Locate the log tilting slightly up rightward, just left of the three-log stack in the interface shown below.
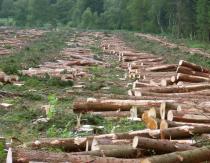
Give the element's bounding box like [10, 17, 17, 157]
[146, 64, 177, 72]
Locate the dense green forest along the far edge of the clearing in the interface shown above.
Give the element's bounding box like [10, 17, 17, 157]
[0, 0, 210, 40]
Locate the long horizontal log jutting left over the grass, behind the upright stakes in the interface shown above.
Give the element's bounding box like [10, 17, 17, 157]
[74, 98, 173, 112]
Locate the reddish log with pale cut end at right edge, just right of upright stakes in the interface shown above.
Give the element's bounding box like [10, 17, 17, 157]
[167, 110, 210, 123]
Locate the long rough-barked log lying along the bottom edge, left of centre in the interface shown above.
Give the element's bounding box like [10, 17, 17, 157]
[13, 149, 140, 163]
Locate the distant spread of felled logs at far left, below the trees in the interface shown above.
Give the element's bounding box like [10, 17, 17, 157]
[0, 29, 47, 56]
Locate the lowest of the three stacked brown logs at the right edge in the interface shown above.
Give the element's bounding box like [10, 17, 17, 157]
[177, 73, 210, 83]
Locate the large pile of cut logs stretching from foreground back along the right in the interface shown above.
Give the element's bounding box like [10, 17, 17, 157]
[9, 36, 210, 163]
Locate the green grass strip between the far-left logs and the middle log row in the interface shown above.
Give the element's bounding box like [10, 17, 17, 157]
[0, 30, 71, 74]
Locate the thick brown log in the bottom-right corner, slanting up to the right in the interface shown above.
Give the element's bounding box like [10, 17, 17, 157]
[141, 146, 210, 163]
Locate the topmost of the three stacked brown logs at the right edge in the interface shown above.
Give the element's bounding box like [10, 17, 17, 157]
[179, 60, 210, 73]
